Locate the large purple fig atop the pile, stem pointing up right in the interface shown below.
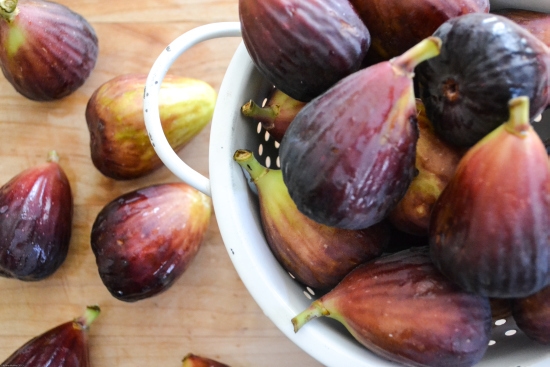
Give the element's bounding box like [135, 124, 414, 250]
[280, 37, 440, 229]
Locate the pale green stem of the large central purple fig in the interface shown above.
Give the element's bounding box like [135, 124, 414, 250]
[390, 37, 442, 78]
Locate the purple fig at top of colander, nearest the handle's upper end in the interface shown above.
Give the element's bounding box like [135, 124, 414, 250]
[239, 0, 370, 102]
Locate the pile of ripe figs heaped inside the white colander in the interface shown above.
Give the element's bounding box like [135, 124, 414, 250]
[240, 0, 550, 367]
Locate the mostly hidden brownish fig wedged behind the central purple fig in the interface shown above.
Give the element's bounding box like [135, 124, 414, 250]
[388, 99, 463, 236]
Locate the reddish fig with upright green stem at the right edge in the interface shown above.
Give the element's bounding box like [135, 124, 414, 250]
[429, 96, 550, 298]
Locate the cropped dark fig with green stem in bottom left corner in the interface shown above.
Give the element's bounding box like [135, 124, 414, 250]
[0, 306, 100, 367]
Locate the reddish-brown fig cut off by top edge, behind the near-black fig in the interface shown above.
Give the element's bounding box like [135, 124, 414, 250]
[350, 0, 489, 61]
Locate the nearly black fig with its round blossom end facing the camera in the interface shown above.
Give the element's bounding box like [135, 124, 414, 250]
[416, 13, 550, 147]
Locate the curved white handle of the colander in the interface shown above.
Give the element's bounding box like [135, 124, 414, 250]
[143, 22, 241, 196]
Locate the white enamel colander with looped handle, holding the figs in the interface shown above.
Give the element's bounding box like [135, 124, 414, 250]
[144, 0, 550, 367]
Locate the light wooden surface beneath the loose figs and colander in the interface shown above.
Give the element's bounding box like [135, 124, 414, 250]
[0, 0, 319, 367]
